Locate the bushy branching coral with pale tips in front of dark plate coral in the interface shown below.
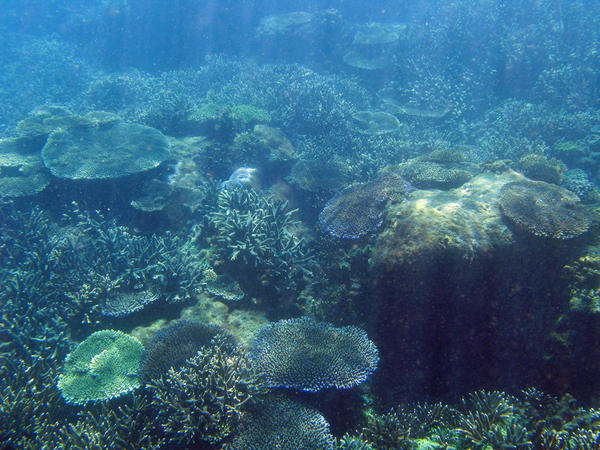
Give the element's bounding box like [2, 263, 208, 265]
[147, 345, 266, 444]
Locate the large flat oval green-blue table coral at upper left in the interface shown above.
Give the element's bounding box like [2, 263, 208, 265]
[42, 118, 170, 180]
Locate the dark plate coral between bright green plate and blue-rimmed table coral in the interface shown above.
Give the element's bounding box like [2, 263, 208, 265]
[140, 320, 235, 382]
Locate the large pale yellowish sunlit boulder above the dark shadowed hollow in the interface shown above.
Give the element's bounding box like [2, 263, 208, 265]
[370, 172, 520, 270]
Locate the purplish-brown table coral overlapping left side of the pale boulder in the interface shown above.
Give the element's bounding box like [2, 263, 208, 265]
[319, 172, 413, 239]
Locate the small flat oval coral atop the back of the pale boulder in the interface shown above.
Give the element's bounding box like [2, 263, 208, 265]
[398, 158, 472, 189]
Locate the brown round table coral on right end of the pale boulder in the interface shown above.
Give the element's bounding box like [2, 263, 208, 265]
[499, 180, 592, 239]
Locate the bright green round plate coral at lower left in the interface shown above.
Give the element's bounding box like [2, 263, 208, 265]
[58, 330, 144, 405]
